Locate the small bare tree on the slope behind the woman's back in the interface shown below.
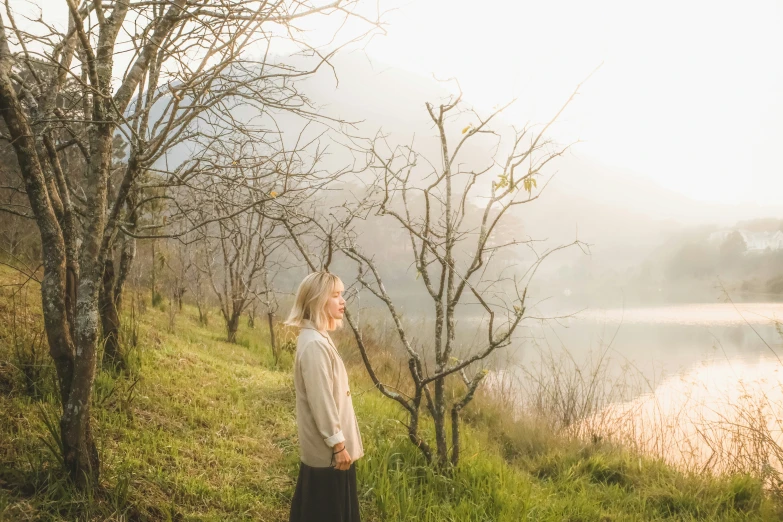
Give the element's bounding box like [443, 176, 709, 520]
[199, 136, 304, 343]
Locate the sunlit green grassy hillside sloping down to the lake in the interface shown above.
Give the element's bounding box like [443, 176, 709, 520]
[0, 271, 783, 522]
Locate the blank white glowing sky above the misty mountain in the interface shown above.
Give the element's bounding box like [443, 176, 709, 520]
[367, 0, 783, 204]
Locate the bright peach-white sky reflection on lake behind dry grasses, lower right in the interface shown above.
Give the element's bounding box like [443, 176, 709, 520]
[578, 356, 783, 480]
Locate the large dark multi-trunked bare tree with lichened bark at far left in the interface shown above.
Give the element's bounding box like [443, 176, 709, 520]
[0, 0, 377, 485]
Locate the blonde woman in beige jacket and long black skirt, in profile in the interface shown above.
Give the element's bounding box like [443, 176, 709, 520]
[286, 272, 364, 522]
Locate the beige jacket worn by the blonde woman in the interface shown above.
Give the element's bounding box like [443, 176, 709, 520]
[294, 322, 364, 468]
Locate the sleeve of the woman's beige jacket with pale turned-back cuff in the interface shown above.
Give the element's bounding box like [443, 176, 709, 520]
[300, 341, 345, 447]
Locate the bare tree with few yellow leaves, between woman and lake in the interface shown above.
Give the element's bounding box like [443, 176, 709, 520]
[292, 85, 586, 468]
